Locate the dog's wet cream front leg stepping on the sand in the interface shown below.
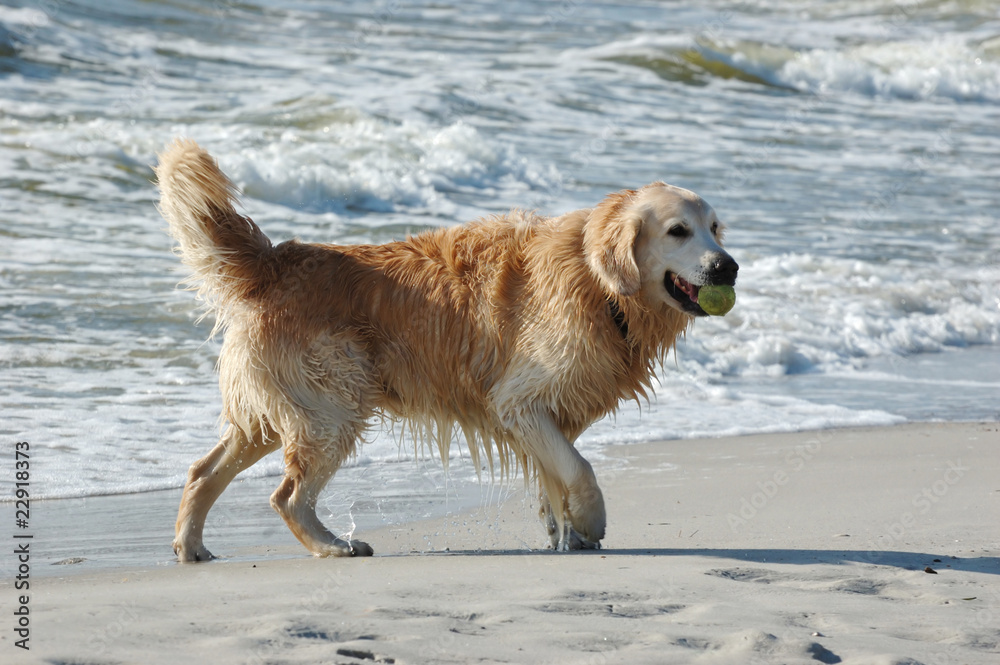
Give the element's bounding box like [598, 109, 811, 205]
[513, 411, 607, 550]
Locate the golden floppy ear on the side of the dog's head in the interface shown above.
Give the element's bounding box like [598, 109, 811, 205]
[583, 190, 644, 296]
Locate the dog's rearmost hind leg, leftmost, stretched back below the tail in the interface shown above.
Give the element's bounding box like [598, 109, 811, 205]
[174, 424, 281, 562]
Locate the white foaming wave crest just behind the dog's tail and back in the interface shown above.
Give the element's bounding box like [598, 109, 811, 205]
[219, 114, 560, 216]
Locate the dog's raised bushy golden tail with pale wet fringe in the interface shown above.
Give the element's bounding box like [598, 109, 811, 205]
[156, 139, 274, 327]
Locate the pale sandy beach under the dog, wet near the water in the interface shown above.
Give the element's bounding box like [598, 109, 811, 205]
[0, 423, 1000, 665]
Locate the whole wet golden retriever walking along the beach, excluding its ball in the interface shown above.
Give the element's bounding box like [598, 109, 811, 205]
[156, 140, 738, 561]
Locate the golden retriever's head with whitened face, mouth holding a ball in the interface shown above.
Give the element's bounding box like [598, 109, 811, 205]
[584, 182, 739, 316]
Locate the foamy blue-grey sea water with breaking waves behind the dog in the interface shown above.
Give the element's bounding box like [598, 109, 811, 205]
[0, 0, 1000, 508]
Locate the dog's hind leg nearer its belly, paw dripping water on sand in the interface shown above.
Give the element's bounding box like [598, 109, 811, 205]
[271, 426, 372, 557]
